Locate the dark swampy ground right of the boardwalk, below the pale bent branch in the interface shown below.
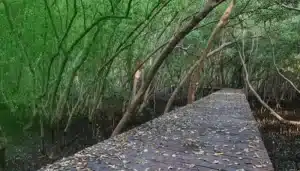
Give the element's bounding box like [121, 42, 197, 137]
[256, 111, 300, 171]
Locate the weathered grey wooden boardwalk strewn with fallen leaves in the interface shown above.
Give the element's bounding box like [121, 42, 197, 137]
[40, 89, 274, 171]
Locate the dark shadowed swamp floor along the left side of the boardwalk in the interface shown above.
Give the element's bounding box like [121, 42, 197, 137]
[0, 104, 98, 171]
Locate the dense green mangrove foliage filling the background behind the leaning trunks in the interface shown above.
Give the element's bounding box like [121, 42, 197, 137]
[0, 0, 300, 128]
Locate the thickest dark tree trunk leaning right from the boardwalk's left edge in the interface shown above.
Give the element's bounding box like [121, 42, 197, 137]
[111, 0, 226, 137]
